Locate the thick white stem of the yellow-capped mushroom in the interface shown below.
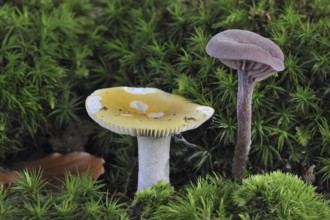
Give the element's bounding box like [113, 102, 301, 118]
[137, 136, 171, 191]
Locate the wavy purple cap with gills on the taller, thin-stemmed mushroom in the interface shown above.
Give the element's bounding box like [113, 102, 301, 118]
[206, 29, 284, 81]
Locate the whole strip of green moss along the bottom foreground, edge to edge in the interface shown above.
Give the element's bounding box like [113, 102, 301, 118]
[0, 172, 330, 220]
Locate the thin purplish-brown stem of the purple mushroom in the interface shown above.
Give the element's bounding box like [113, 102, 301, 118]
[232, 70, 254, 181]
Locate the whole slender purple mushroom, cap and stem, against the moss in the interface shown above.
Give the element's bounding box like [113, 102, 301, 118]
[206, 29, 284, 180]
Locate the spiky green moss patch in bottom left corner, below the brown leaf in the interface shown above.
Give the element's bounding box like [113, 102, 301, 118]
[0, 172, 128, 220]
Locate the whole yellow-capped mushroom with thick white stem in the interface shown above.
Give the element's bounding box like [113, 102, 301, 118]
[86, 87, 214, 191]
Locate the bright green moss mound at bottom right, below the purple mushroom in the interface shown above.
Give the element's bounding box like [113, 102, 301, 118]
[150, 171, 330, 219]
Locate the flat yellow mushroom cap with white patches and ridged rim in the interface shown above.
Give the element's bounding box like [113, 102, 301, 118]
[86, 87, 214, 137]
